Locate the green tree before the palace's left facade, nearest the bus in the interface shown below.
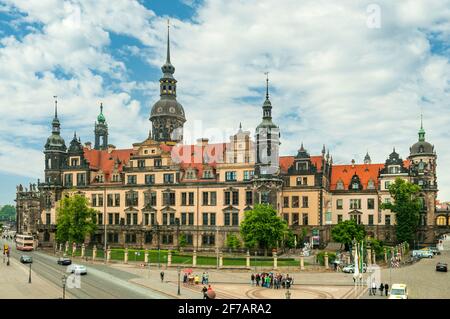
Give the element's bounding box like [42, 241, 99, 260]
[56, 194, 97, 243]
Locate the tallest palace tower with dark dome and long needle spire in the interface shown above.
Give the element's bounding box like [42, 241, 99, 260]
[150, 21, 186, 143]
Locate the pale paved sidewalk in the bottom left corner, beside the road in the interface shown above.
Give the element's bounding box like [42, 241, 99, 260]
[0, 256, 61, 299]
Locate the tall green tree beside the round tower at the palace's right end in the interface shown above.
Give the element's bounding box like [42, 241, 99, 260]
[381, 178, 422, 243]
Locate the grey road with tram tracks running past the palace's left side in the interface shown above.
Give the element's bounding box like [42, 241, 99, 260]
[1, 241, 171, 299]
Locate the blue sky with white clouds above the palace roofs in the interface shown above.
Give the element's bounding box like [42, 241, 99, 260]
[0, 0, 450, 204]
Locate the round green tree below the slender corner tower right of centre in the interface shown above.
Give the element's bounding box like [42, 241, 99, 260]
[240, 204, 288, 255]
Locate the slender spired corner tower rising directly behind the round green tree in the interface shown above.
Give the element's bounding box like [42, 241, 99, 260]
[253, 73, 283, 209]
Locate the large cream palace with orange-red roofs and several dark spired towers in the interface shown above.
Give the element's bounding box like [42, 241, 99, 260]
[16, 26, 444, 250]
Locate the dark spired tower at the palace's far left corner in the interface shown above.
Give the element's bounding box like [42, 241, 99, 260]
[44, 99, 67, 186]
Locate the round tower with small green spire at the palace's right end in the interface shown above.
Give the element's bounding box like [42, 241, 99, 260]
[408, 119, 438, 226]
